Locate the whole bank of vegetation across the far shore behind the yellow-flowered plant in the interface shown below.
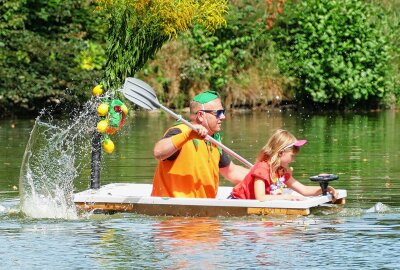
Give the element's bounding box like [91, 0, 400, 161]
[0, 0, 400, 118]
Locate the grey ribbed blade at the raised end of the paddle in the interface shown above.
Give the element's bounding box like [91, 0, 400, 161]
[122, 77, 160, 110]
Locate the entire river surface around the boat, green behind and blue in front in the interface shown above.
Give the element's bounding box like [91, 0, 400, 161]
[0, 111, 400, 269]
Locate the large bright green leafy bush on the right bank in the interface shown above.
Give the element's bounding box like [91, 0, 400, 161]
[272, 0, 393, 107]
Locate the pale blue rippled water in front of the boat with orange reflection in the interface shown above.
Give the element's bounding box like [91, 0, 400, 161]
[0, 197, 400, 269]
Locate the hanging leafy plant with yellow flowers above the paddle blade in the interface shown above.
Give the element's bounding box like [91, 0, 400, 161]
[97, 0, 227, 86]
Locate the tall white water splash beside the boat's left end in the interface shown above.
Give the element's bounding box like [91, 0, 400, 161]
[19, 101, 97, 219]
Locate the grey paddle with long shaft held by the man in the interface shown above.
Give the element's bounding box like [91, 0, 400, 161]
[122, 77, 253, 168]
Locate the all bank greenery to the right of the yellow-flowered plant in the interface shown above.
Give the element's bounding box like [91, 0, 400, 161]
[142, 0, 400, 109]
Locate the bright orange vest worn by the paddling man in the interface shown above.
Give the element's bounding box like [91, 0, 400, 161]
[151, 124, 221, 198]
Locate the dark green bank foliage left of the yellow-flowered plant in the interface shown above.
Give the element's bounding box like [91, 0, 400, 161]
[0, 0, 105, 114]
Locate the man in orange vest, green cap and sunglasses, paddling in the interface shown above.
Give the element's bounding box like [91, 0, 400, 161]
[151, 90, 249, 198]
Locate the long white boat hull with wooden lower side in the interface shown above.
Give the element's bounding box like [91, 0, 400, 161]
[74, 183, 347, 216]
